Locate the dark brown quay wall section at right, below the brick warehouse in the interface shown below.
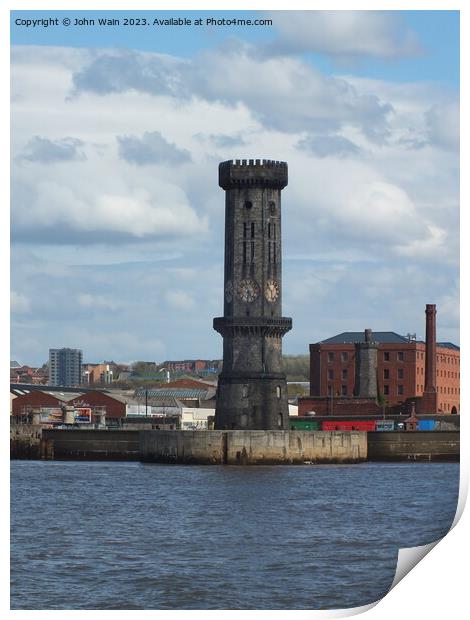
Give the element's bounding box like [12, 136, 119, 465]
[367, 431, 460, 461]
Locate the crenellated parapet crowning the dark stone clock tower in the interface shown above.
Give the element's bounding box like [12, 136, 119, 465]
[219, 159, 287, 190]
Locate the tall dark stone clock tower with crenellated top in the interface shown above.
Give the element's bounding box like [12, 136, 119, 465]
[214, 159, 292, 430]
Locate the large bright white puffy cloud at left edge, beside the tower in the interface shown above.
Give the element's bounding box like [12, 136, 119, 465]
[12, 149, 207, 243]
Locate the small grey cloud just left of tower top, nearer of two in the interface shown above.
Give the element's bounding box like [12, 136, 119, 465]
[117, 131, 191, 166]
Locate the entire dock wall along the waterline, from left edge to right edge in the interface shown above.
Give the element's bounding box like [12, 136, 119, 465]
[10, 424, 460, 465]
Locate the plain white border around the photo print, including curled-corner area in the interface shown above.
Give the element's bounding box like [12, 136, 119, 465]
[0, 0, 470, 620]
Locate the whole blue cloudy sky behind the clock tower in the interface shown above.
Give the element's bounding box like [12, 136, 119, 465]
[11, 11, 460, 365]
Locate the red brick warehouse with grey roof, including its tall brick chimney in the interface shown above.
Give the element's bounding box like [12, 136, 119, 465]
[300, 304, 460, 415]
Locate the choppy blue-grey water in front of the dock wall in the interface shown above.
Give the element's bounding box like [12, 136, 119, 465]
[11, 461, 459, 609]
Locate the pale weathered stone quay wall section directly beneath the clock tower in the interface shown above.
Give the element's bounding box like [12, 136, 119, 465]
[140, 431, 367, 465]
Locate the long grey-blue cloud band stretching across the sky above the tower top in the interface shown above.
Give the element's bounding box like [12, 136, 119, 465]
[73, 42, 392, 142]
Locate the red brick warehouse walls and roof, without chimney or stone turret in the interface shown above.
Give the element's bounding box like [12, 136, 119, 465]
[299, 306, 460, 415]
